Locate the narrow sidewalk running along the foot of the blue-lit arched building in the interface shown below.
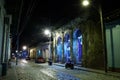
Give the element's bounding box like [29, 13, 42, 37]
[53, 63, 120, 78]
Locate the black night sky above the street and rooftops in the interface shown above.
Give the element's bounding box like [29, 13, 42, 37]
[5, 0, 119, 49]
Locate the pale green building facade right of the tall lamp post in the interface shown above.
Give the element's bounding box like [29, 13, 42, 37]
[105, 19, 120, 72]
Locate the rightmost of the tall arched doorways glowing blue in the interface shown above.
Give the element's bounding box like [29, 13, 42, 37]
[73, 29, 82, 64]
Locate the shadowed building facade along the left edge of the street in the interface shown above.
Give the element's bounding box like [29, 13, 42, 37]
[0, 0, 11, 76]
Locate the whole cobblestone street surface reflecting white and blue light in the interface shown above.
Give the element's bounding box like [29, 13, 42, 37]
[2, 60, 120, 80]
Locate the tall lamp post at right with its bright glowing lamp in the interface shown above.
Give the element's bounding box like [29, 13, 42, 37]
[82, 0, 107, 72]
